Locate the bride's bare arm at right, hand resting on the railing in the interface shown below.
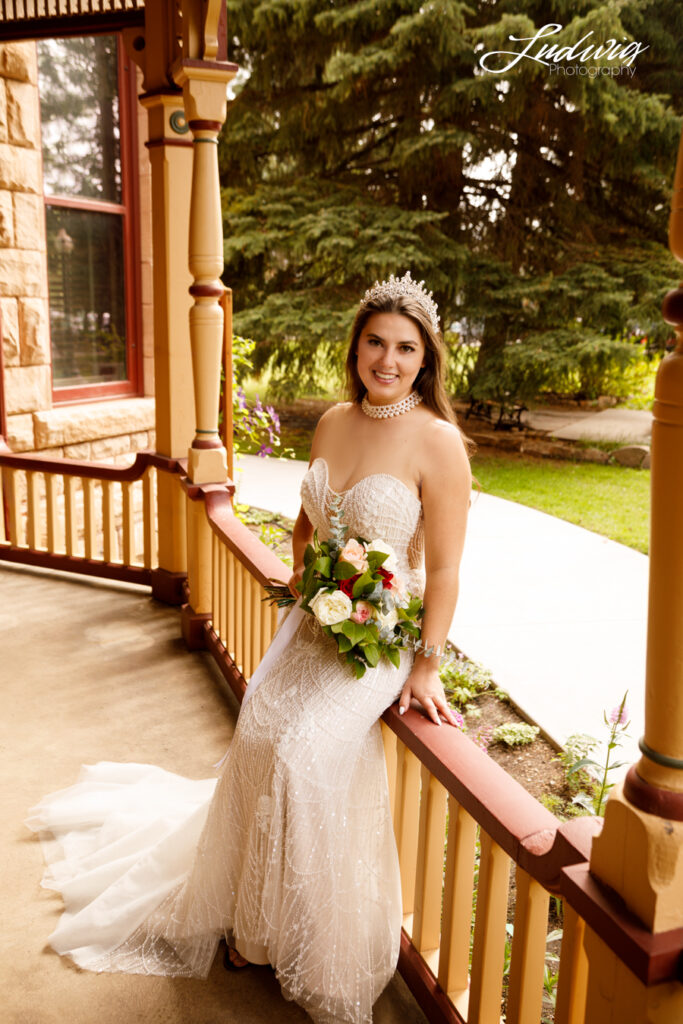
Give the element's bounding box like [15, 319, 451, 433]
[398, 421, 472, 725]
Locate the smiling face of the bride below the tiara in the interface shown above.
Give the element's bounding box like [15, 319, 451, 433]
[356, 313, 425, 406]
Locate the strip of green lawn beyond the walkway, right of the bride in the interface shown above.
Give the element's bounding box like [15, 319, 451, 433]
[472, 456, 650, 554]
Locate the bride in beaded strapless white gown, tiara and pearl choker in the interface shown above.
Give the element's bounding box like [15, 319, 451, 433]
[28, 272, 471, 1024]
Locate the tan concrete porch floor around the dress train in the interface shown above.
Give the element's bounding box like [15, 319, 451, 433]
[0, 566, 426, 1024]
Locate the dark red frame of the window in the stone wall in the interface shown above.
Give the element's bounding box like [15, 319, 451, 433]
[38, 30, 142, 407]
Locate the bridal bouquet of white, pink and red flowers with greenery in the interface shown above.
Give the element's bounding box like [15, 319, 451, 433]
[267, 499, 434, 679]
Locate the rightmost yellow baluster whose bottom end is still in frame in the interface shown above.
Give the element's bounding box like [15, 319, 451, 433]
[438, 796, 477, 1003]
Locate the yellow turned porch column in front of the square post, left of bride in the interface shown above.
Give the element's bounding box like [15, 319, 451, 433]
[173, 0, 237, 647]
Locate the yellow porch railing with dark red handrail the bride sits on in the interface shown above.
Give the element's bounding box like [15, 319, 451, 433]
[0, 447, 683, 1024]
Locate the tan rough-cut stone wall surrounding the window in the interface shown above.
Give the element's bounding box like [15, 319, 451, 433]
[0, 42, 155, 461]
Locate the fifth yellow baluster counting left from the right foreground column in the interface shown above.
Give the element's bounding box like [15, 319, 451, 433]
[413, 765, 449, 973]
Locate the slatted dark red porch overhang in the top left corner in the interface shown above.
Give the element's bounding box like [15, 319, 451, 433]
[0, 0, 144, 42]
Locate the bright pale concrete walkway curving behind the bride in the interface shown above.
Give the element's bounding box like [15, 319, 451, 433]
[237, 452, 648, 777]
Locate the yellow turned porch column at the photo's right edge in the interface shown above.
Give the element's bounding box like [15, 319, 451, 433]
[586, 125, 683, 1024]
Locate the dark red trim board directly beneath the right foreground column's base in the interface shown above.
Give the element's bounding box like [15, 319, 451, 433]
[562, 864, 683, 985]
